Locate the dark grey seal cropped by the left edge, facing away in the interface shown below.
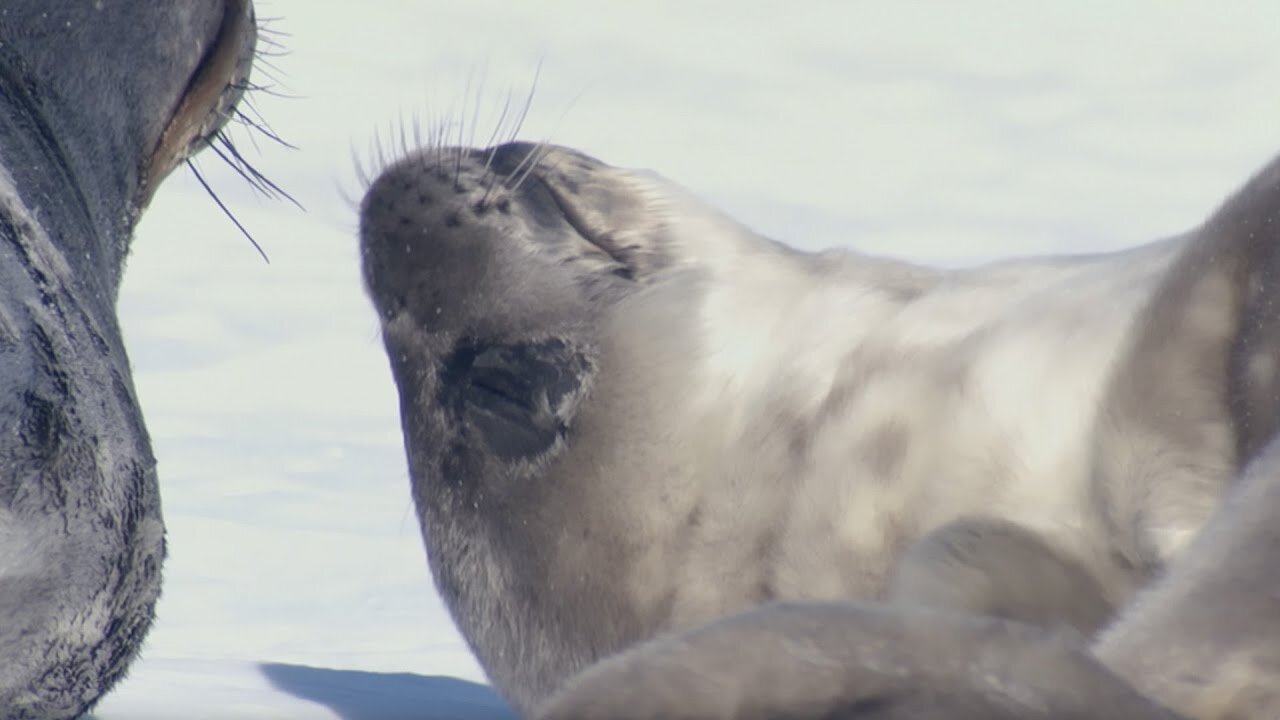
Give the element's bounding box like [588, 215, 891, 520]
[0, 0, 256, 719]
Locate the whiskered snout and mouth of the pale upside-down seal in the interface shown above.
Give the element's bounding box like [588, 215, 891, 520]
[361, 142, 669, 327]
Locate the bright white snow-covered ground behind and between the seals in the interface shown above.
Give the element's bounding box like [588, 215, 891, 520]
[95, 0, 1280, 720]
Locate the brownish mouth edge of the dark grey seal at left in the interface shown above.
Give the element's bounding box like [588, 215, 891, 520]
[137, 0, 257, 208]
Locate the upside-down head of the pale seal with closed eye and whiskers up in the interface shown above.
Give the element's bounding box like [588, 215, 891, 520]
[361, 142, 808, 707]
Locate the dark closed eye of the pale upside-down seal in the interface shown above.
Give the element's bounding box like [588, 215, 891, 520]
[440, 338, 589, 461]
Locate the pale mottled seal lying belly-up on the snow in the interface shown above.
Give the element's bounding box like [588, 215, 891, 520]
[361, 143, 1280, 719]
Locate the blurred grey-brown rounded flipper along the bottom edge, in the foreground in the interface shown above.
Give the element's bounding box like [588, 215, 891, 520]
[535, 603, 1179, 720]
